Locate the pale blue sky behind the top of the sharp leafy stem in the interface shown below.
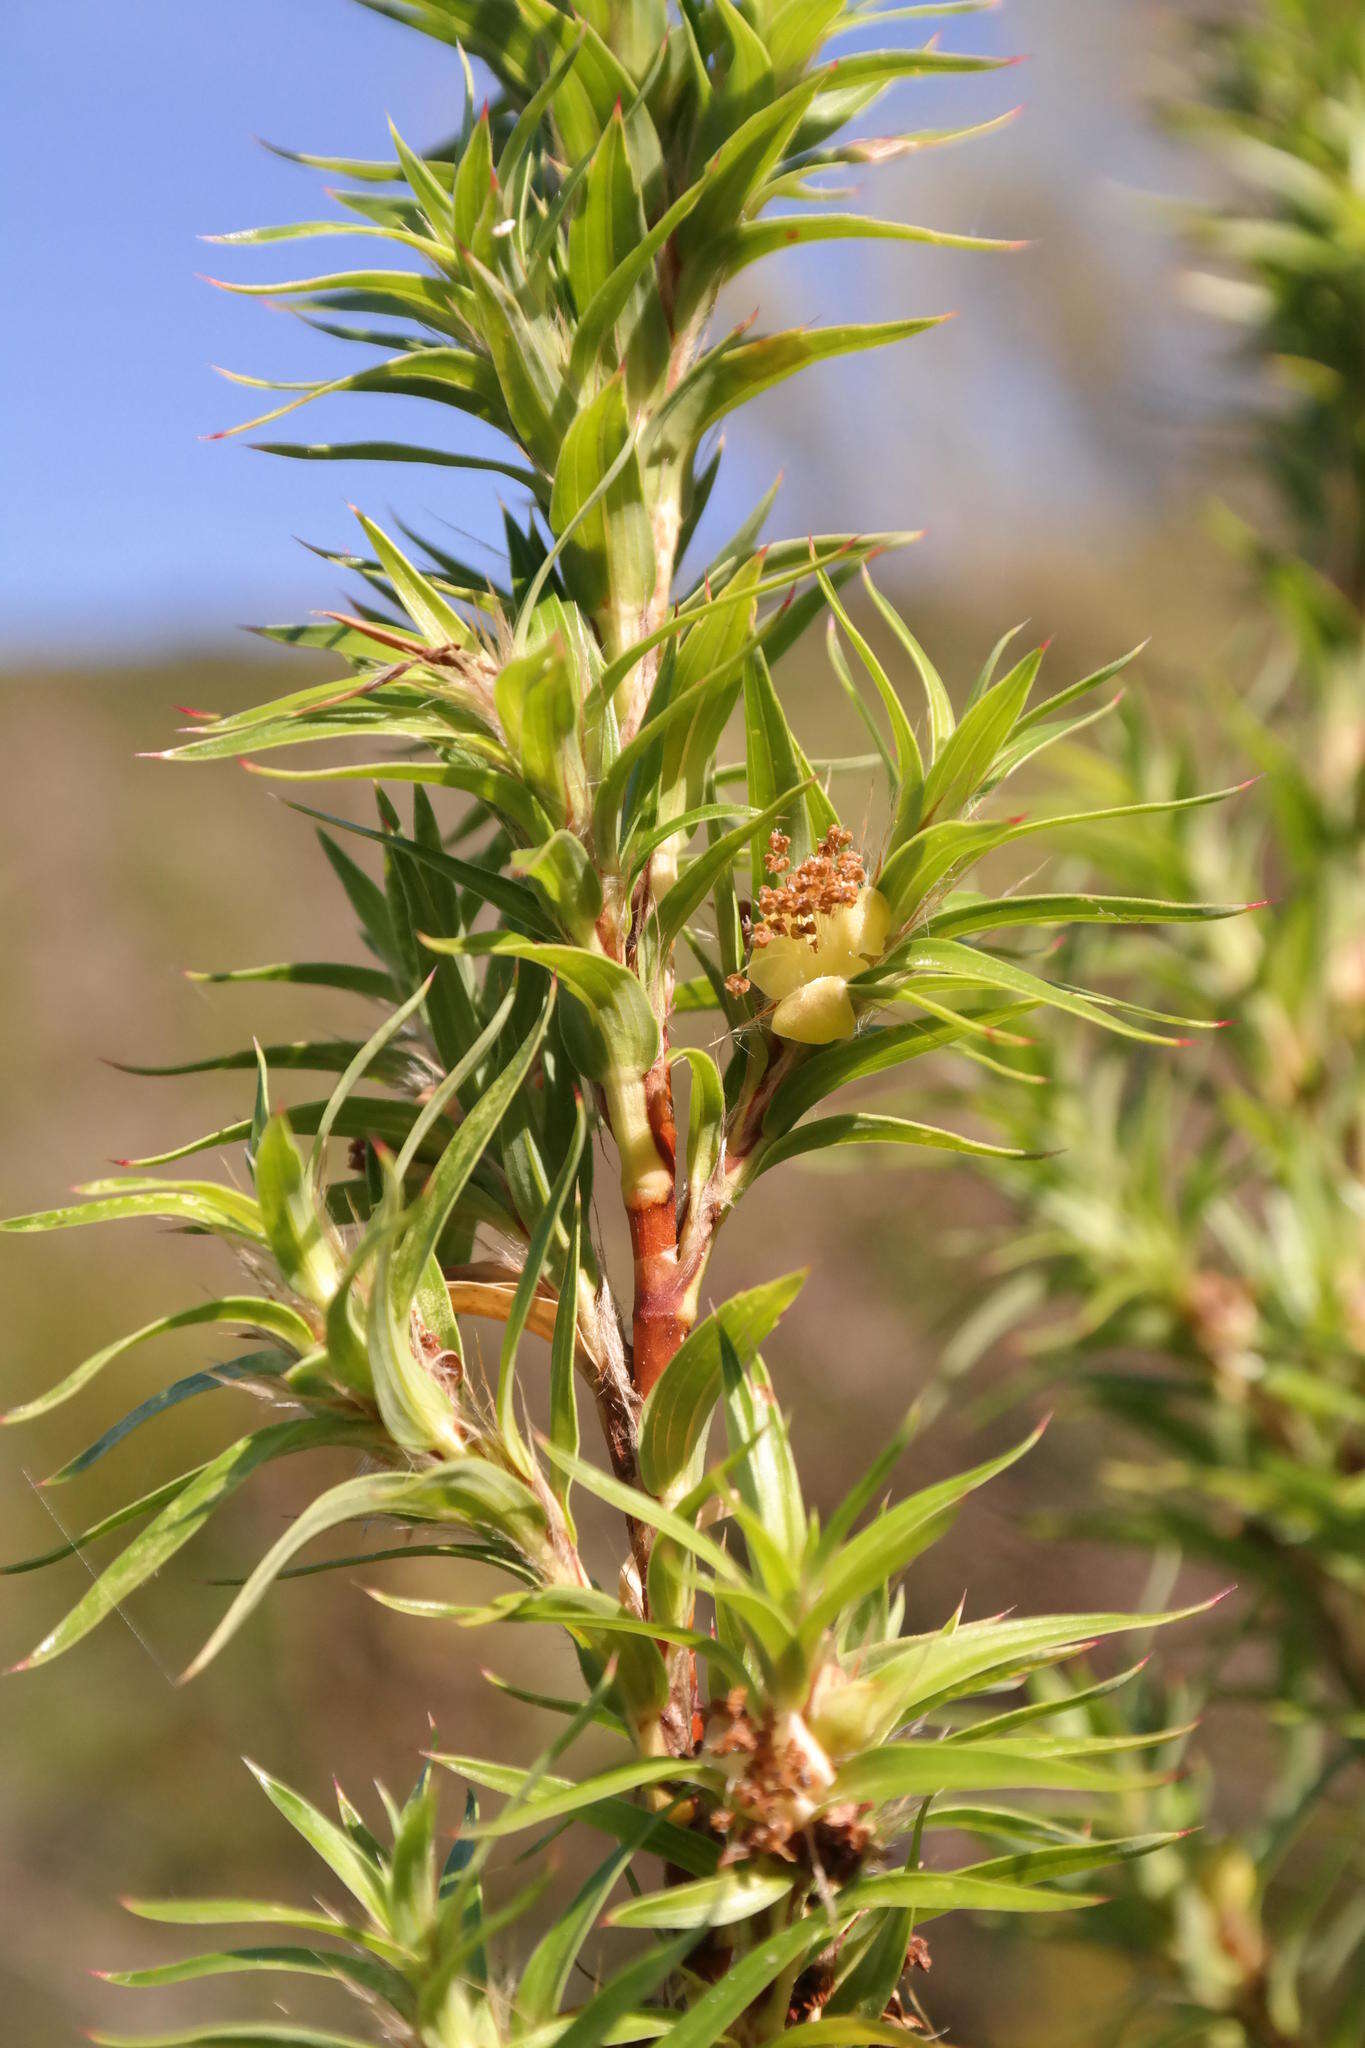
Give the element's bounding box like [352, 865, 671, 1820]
[0, 0, 1203, 655]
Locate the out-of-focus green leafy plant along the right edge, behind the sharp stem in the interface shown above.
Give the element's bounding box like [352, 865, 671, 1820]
[948, 0, 1365, 2048]
